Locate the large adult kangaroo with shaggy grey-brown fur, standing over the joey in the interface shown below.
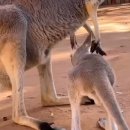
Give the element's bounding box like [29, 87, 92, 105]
[0, 0, 104, 130]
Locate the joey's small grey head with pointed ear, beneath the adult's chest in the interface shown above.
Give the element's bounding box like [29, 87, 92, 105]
[71, 34, 92, 66]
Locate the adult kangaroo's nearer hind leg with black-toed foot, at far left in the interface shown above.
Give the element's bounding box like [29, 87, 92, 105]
[0, 5, 58, 130]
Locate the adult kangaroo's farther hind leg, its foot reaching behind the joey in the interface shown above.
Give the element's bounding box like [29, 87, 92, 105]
[38, 59, 69, 106]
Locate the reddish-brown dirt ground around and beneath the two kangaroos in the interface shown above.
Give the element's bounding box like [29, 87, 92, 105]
[0, 4, 130, 130]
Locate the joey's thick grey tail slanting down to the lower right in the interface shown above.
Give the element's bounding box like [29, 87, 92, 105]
[95, 77, 129, 130]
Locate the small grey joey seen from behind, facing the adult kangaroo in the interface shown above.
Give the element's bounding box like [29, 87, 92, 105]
[68, 35, 129, 130]
